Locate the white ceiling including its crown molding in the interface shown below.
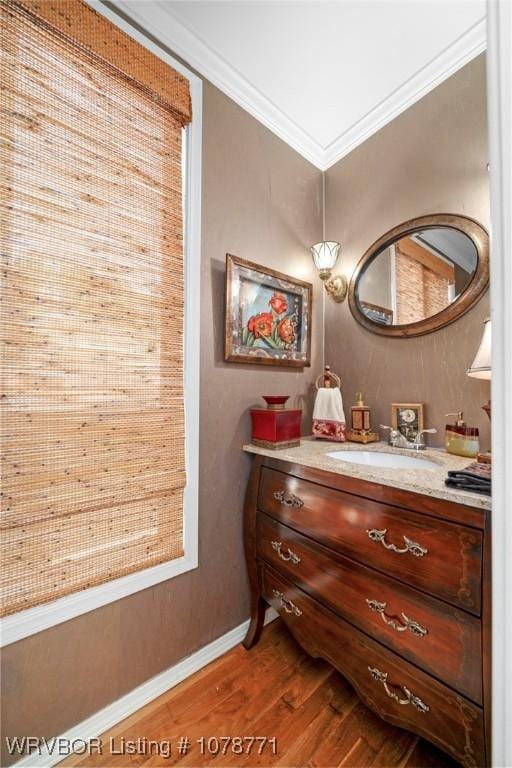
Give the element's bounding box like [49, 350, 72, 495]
[115, 0, 485, 170]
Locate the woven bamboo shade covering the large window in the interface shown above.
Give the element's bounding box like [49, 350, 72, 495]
[0, 0, 191, 615]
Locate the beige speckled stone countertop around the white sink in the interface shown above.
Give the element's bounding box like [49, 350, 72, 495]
[243, 437, 491, 509]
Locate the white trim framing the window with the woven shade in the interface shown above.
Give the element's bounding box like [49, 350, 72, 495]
[0, 0, 203, 646]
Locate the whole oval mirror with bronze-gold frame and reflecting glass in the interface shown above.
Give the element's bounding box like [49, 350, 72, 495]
[349, 214, 489, 336]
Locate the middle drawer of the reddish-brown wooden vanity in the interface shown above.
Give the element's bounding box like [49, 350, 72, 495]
[257, 512, 482, 704]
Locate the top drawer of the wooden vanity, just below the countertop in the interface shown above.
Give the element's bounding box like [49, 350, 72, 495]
[258, 468, 482, 615]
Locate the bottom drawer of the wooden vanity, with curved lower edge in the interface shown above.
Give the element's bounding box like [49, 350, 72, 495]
[261, 567, 485, 768]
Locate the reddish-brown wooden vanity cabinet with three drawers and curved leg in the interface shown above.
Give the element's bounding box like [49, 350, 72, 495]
[244, 456, 490, 768]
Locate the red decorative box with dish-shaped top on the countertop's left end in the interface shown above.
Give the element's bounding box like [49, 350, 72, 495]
[250, 395, 302, 450]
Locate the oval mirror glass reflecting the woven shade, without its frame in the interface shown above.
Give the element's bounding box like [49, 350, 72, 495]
[355, 227, 478, 325]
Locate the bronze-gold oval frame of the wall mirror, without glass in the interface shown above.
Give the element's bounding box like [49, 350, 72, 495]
[348, 213, 489, 338]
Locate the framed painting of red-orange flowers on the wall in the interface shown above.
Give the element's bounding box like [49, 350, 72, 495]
[224, 253, 312, 368]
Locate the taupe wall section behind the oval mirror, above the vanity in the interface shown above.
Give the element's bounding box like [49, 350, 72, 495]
[325, 55, 489, 447]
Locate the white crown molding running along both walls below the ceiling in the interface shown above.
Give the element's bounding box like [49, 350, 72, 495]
[110, 0, 486, 171]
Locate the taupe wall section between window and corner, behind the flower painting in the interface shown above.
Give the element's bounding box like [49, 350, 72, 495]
[2, 83, 322, 765]
